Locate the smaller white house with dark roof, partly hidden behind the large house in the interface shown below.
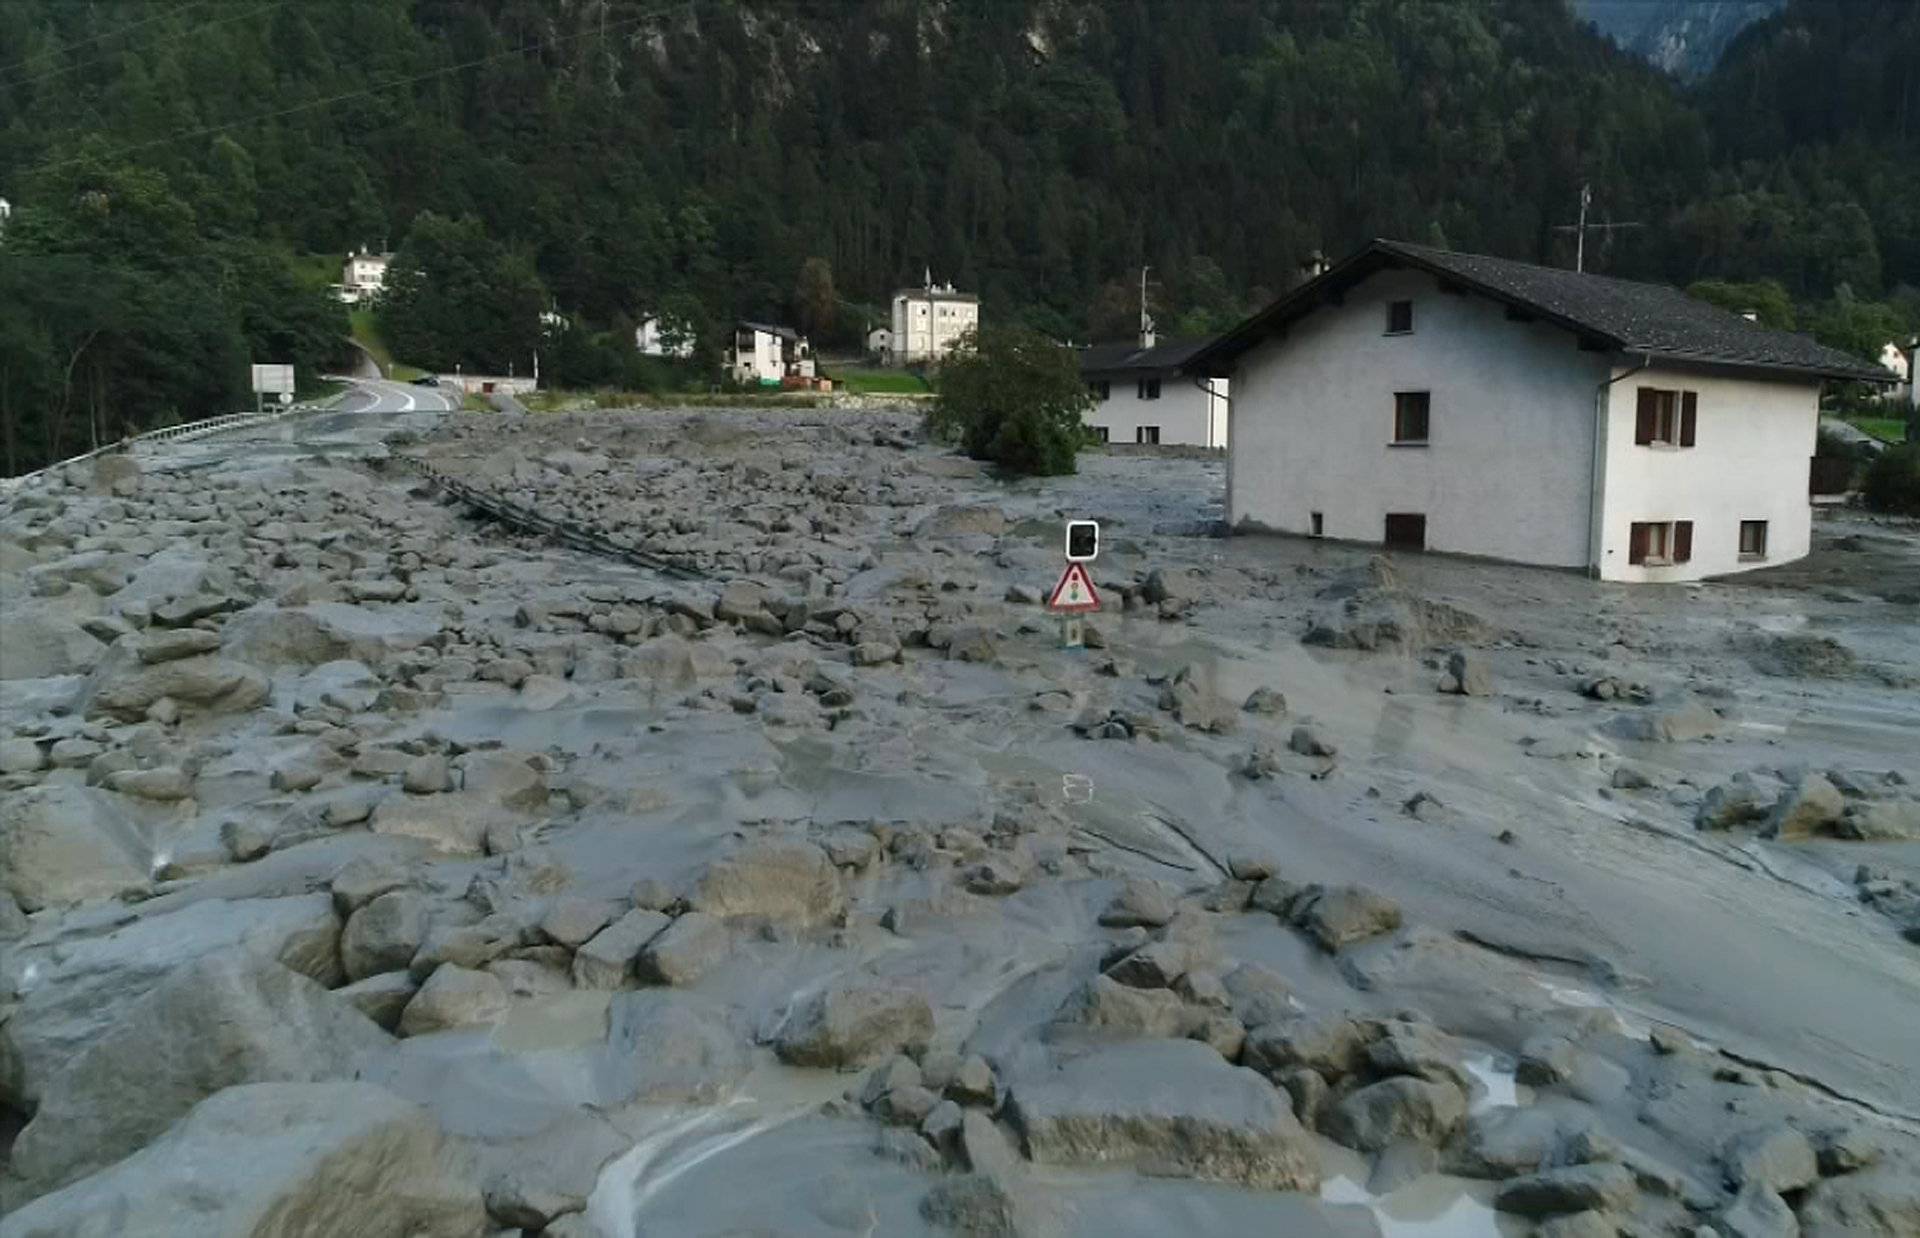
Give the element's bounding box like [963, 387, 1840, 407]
[1079, 330, 1227, 447]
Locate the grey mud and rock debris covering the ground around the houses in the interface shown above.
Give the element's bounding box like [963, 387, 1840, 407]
[0, 401, 1920, 1238]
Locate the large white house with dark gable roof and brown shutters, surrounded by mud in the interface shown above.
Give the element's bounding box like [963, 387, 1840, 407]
[1185, 240, 1887, 582]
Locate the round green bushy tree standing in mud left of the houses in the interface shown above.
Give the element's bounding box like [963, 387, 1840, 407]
[927, 326, 1092, 476]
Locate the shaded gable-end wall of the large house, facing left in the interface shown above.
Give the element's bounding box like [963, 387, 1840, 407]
[1227, 271, 1605, 566]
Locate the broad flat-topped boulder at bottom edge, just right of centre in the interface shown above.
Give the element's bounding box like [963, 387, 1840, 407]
[1008, 1040, 1321, 1190]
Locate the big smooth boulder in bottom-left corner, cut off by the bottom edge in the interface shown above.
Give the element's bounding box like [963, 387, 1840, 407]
[0, 1083, 486, 1238]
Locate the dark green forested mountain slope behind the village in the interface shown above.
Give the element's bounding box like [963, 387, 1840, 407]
[0, 0, 1920, 470]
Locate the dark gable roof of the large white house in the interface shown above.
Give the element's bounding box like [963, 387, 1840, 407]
[1187, 240, 1893, 382]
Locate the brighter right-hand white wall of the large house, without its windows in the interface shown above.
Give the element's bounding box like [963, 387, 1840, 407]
[1599, 367, 1820, 582]
